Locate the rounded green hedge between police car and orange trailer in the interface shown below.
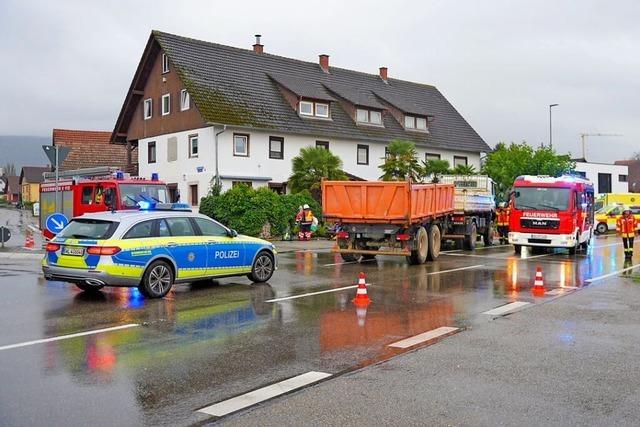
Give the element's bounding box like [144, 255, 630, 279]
[200, 185, 322, 237]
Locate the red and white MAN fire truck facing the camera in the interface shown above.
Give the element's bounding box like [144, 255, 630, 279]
[509, 175, 594, 254]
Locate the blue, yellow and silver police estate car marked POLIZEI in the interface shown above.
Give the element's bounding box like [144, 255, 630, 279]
[42, 202, 276, 298]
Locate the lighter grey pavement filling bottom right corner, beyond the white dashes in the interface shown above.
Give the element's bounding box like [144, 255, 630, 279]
[222, 278, 640, 426]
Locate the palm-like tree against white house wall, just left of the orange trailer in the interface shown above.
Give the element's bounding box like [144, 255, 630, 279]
[289, 147, 347, 196]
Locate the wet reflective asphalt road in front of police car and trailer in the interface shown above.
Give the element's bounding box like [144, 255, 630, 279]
[0, 237, 640, 426]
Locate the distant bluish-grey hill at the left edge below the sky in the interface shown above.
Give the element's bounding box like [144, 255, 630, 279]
[0, 135, 51, 174]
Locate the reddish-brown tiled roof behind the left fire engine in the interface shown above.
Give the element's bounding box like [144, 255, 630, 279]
[53, 129, 133, 171]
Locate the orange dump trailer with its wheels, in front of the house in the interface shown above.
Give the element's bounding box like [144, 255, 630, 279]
[322, 181, 454, 264]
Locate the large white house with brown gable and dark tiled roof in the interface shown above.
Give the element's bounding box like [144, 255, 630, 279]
[111, 31, 490, 205]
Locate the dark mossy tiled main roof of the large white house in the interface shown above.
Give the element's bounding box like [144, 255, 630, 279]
[152, 31, 491, 152]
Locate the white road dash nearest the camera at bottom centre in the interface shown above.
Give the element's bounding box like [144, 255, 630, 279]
[198, 371, 331, 417]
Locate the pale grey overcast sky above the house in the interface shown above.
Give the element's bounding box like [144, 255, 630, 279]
[0, 0, 640, 162]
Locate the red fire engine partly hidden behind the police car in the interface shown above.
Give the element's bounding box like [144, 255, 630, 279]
[39, 167, 173, 239]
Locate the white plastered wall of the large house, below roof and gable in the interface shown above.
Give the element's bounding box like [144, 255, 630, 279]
[138, 127, 480, 206]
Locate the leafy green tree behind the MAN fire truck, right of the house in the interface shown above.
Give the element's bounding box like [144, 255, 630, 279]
[482, 142, 575, 200]
